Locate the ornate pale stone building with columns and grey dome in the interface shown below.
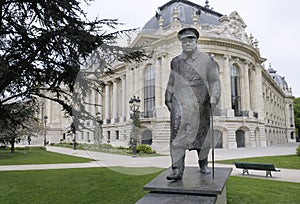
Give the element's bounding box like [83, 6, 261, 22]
[43, 0, 295, 151]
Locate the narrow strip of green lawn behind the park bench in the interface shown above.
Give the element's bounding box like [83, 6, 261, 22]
[216, 154, 300, 169]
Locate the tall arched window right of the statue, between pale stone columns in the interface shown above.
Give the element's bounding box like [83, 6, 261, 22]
[230, 65, 241, 116]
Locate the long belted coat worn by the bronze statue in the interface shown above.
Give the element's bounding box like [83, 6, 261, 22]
[165, 50, 221, 156]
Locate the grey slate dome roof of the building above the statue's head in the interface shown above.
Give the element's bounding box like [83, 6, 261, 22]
[142, 0, 222, 33]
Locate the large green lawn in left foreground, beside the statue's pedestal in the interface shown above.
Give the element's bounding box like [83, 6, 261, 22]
[0, 168, 163, 204]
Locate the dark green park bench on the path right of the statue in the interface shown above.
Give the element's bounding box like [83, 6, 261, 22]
[234, 162, 280, 177]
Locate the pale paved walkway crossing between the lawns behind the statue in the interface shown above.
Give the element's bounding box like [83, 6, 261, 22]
[0, 143, 300, 183]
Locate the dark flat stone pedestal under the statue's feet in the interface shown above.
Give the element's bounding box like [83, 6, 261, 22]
[137, 167, 232, 204]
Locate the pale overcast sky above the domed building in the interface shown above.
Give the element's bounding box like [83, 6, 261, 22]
[81, 0, 300, 97]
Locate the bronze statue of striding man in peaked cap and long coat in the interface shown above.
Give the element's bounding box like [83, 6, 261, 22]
[165, 28, 221, 180]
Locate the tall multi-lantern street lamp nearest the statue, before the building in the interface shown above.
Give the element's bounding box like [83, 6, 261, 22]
[129, 96, 141, 157]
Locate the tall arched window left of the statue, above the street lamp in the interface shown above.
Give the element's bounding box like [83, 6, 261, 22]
[144, 65, 155, 118]
